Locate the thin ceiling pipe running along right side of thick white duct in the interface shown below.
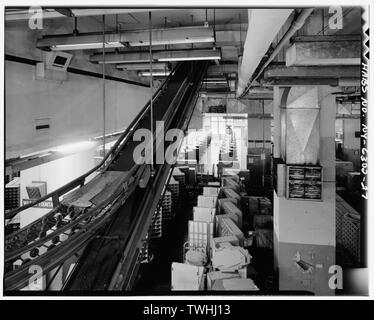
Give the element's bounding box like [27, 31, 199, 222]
[239, 8, 314, 99]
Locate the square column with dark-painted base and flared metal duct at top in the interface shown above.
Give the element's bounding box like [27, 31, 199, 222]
[274, 86, 335, 295]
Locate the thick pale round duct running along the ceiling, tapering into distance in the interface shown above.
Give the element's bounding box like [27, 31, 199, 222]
[236, 9, 293, 96]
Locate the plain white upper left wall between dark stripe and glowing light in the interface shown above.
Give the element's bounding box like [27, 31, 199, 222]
[5, 61, 149, 158]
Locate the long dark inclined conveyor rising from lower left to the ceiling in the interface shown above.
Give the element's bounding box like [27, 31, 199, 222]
[4, 62, 207, 291]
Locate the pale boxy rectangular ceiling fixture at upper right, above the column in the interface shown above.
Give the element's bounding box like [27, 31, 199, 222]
[286, 41, 361, 66]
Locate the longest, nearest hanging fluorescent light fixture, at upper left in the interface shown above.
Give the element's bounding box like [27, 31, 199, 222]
[36, 27, 214, 51]
